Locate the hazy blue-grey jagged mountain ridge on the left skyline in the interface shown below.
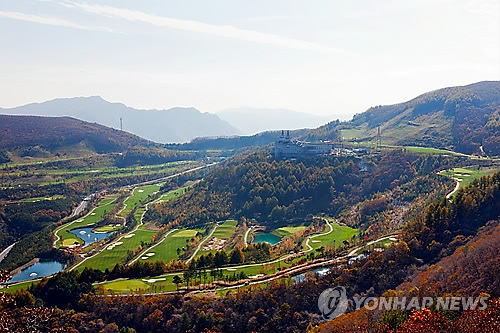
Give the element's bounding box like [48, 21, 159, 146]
[0, 96, 240, 143]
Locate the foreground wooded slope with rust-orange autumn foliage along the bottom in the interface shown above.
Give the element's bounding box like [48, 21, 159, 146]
[0, 173, 500, 333]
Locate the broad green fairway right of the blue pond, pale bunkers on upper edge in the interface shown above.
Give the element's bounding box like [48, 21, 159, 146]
[77, 230, 154, 271]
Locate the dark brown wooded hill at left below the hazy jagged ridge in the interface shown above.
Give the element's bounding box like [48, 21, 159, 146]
[0, 115, 195, 167]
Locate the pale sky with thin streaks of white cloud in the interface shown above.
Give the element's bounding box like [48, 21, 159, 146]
[0, 0, 500, 119]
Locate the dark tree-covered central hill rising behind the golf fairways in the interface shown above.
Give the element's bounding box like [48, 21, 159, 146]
[153, 150, 460, 225]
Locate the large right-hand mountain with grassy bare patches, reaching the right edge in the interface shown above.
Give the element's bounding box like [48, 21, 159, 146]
[304, 81, 500, 155]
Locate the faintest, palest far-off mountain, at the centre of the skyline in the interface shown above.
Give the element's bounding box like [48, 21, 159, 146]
[217, 108, 339, 135]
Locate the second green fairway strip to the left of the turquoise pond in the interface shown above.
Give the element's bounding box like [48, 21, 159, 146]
[139, 229, 198, 263]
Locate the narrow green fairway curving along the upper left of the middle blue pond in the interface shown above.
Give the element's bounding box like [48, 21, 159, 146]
[55, 195, 116, 247]
